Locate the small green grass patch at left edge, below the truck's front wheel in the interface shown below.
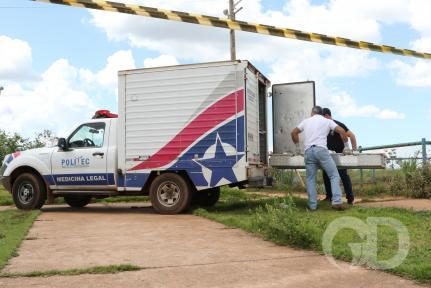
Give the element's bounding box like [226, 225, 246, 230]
[0, 210, 40, 270]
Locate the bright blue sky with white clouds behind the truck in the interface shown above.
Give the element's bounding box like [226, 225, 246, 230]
[0, 0, 431, 153]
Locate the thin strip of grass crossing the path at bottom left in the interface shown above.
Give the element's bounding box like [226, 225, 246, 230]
[0, 264, 144, 278]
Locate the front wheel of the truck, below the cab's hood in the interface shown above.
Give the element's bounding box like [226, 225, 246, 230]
[12, 173, 47, 210]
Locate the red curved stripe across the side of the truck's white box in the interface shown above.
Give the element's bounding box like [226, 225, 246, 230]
[129, 89, 244, 171]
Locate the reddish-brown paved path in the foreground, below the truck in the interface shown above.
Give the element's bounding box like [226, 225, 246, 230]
[0, 204, 426, 288]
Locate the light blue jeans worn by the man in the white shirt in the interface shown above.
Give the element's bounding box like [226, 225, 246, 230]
[304, 146, 342, 210]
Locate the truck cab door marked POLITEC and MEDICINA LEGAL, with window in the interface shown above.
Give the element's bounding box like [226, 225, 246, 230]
[51, 121, 113, 190]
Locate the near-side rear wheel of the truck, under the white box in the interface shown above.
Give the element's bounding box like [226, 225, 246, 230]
[150, 173, 192, 215]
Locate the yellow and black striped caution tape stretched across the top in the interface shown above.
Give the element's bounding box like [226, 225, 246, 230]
[32, 0, 431, 59]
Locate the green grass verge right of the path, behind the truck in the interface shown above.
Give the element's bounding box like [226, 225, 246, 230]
[193, 189, 431, 283]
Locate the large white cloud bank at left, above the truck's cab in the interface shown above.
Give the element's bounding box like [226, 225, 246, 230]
[0, 36, 135, 137]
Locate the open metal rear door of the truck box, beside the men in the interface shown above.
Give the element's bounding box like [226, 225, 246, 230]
[272, 81, 316, 154]
